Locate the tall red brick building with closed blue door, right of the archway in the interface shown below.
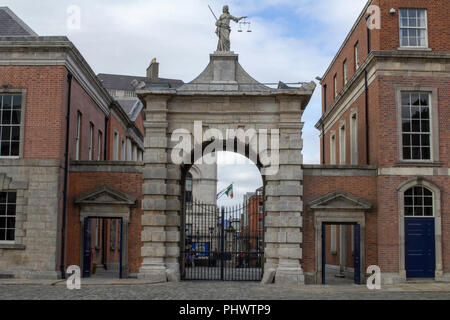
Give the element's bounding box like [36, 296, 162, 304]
[310, 0, 450, 282]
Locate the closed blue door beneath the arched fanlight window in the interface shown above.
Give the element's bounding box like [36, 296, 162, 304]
[405, 218, 436, 278]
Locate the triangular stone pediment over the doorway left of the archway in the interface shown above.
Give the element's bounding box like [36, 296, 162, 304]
[75, 186, 136, 205]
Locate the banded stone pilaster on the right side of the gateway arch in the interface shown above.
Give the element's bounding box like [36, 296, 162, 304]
[266, 98, 305, 285]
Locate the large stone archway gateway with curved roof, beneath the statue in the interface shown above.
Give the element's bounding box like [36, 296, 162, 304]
[137, 52, 316, 284]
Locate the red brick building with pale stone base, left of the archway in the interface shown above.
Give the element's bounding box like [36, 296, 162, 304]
[0, 8, 178, 278]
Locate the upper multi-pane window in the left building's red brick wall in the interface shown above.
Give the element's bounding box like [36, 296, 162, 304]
[0, 94, 22, 157]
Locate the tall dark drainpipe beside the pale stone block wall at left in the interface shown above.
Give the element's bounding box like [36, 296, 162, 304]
[60, 73, 73, 279]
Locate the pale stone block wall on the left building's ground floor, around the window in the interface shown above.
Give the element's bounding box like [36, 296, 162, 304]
[0, 159, 62, 279]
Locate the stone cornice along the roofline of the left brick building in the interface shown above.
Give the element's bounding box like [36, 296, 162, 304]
[0, 37, 113, 115]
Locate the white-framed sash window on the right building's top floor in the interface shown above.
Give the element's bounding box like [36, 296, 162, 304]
[400, 9, 428, 48]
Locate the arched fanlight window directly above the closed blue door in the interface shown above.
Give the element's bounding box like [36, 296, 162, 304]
[405, 187, 434, 217]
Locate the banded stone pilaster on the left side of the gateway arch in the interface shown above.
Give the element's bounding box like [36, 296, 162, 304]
[138, 96, 168, 281]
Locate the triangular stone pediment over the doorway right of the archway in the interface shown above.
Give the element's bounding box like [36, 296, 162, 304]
[308, 191, 372, 211]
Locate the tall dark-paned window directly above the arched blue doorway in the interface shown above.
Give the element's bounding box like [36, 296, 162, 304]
[402, 92, 431, 160]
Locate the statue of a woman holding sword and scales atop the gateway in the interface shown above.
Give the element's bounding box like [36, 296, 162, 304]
[208, 5, 252, 52]
